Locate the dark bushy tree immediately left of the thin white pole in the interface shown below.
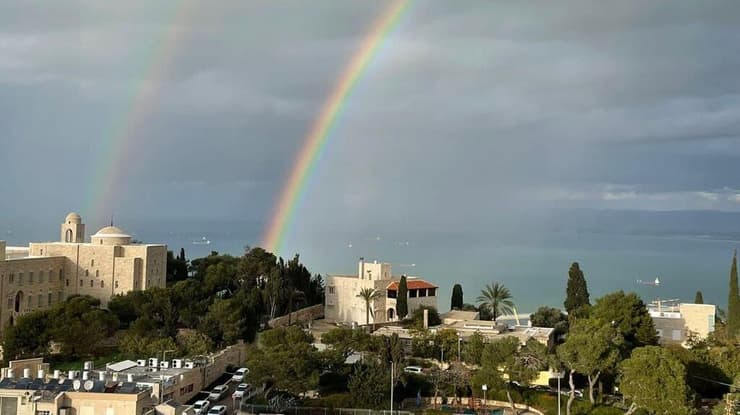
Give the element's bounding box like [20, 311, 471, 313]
[347, 360, 390, 409]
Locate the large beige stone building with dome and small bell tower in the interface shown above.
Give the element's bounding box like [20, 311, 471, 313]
[0, 213, 167, 334]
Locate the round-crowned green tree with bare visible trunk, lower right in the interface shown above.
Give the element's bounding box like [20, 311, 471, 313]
[558, 319, 624, 404]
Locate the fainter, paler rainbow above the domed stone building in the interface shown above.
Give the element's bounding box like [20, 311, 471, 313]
[82, 0, 197, 224]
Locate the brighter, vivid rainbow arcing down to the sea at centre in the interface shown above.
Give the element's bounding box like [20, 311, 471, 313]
[262, 0, 410, 255]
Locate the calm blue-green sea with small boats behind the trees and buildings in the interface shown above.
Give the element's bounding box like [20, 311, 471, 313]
[0, 211, 740, 313]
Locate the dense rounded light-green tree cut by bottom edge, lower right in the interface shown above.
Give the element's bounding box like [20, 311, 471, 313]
[619, 346, 693, 415]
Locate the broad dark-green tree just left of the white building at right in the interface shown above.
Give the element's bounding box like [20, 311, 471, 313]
[591, 291, 658, 357]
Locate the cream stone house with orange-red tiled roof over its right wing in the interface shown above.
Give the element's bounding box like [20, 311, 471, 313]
[324, 258, 438, 324]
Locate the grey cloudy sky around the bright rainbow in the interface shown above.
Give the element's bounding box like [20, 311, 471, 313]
[0, 0, 740, 247]
